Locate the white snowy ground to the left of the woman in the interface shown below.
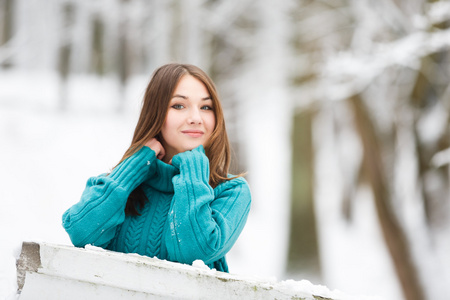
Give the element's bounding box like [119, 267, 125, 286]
[0, 69, 144, 299]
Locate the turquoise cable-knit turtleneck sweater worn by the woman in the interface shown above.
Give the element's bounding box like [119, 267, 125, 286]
[63, 146, 251, 272]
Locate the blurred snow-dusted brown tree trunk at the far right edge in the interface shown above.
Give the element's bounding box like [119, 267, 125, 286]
[411, 51, 450, 227]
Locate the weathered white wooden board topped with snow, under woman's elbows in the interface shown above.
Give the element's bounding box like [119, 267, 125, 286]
[17, 242, 360, 300]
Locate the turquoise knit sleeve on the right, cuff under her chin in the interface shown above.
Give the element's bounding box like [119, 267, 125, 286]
[164, 146, 251, 264]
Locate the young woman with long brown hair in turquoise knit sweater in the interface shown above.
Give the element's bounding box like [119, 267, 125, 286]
[63, 64, 251, 272]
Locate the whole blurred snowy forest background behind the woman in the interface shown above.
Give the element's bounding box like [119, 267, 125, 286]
[0, 0, 450, 300]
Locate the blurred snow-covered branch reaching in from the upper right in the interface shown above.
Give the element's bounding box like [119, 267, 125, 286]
[317, 29, 450, 100]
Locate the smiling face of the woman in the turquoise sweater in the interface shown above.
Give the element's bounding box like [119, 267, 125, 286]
[161, 75, 216, 162]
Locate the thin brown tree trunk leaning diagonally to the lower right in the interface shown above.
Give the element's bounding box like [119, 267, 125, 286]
[349, 95, 425, 300]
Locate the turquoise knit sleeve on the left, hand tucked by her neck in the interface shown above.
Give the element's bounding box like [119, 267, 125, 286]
[62, 147, 156, 248]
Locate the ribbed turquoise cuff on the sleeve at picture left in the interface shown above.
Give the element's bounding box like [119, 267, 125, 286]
[109, 146, 157, 192]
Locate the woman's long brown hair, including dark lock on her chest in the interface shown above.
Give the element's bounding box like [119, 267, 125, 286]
[119, 63, 240, 215]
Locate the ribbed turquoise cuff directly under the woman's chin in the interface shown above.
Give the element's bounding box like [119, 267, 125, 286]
[172, 145, 209, 183]
